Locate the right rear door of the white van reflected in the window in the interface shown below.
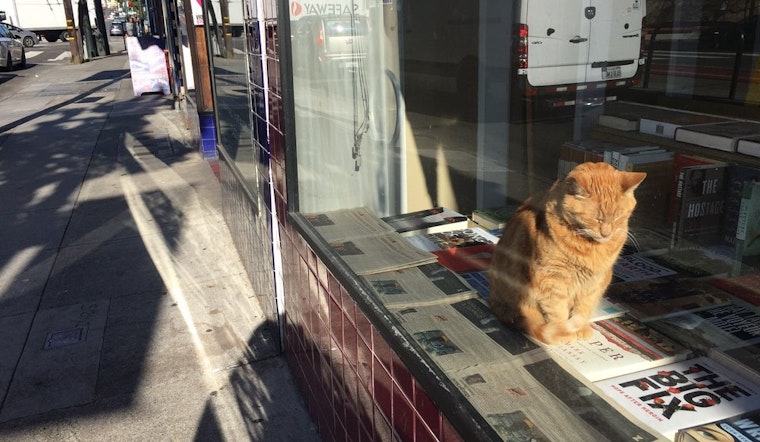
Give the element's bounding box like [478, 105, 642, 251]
[586, 0, 644, 82]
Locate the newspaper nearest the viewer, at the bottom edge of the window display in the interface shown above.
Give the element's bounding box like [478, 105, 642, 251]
[451, 360, 659, 442]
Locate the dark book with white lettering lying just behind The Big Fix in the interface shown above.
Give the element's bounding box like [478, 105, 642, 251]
[647, 299, 760, 354]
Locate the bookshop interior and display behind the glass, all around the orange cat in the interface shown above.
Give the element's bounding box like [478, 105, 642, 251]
[262, 0, 760, 441]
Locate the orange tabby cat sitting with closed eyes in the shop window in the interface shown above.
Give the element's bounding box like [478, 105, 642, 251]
[488, 163, 646, 344]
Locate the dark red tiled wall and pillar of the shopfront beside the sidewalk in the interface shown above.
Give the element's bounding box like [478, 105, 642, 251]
[214, 0, 461, 442]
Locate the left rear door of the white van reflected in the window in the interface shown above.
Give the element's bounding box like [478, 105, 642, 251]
[520, 0, 591, 86]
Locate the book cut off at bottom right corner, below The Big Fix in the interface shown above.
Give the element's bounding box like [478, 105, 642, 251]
[674, 410, 760, 442]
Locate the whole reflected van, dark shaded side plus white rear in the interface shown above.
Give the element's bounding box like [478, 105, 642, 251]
[400, 0, 646, 108]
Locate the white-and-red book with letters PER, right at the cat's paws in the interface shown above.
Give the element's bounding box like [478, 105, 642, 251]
[550, 315, 690, 381]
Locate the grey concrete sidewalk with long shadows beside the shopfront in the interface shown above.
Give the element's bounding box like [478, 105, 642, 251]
[0, 54, 319, 441]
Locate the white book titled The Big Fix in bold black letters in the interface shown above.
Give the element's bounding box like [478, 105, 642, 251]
[594, 357, 760, 440]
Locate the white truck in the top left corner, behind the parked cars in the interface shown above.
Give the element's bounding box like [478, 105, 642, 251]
[0, 0, 70, 42]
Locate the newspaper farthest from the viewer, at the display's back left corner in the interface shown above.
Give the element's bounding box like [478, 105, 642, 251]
[304, 207, 395, 243]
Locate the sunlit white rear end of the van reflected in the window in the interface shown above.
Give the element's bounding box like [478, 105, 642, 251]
[515, 0, 646, 94]
